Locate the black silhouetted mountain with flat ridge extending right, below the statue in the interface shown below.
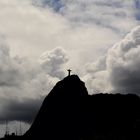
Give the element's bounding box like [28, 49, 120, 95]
[1, 75, 140, 140]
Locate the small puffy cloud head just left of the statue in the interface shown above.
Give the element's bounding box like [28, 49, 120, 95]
[39, 47, 68, 79]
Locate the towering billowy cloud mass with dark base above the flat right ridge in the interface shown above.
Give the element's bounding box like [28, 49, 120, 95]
[84, 26, 140, 94]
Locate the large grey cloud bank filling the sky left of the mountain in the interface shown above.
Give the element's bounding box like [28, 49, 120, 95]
[0, 34, 68, 123]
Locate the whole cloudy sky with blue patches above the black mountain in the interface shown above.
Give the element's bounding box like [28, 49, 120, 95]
[0, 0, 140, 136]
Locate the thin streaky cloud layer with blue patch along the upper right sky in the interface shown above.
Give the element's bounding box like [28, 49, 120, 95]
[33, 0, 139, 33]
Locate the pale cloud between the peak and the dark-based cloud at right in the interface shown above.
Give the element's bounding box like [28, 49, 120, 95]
[83, 56, 111, 94]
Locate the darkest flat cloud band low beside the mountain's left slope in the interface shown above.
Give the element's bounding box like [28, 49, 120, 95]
[0, 97, 43, 123]
